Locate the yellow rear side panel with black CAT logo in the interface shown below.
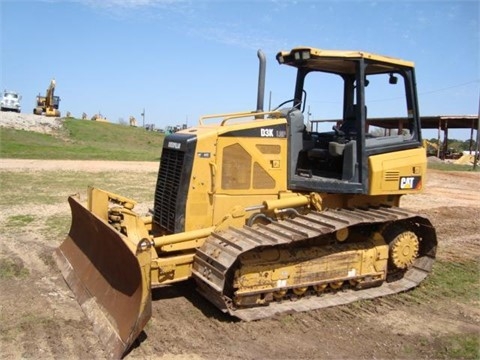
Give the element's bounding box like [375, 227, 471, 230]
[368, 148, 427, 195]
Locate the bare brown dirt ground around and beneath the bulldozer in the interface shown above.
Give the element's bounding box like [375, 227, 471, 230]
[0, 159, 480, 360]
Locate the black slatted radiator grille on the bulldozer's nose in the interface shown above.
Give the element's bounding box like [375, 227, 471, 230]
[153, 148, 185, 233]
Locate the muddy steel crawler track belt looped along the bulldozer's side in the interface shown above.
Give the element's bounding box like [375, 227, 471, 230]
[192, 207, 436, 321]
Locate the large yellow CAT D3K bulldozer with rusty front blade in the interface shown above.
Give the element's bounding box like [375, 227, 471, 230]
[54, 47, 437, 358]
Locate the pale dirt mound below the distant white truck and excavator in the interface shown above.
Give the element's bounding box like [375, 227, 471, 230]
[0, 112, 63, 134]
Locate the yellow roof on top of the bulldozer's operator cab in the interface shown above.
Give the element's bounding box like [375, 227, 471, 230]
[276, 47, 414, 74]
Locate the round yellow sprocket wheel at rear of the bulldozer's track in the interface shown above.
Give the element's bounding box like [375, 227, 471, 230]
[390, 231, 420, 269]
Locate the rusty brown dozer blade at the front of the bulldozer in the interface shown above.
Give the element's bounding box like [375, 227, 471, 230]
[54, 197, 152, 358]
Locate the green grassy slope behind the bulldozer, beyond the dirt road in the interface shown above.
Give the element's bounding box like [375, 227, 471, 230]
[0, 119, 164, 161]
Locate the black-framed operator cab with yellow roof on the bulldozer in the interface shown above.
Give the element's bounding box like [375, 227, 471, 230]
[277, 48, 421, 194]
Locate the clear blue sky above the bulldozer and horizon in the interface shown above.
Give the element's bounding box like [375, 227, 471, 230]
[0, 0, 480, 139]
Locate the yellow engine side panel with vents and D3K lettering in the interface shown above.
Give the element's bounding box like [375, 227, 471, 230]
[213, 125, 288, 226]
